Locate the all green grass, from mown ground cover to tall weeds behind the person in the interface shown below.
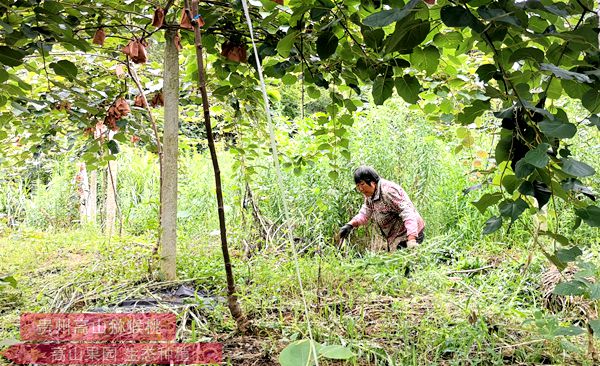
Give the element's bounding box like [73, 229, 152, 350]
[0, 103, 600, 365]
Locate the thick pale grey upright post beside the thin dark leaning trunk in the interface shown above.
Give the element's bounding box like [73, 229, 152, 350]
[160, 28, 179, 281]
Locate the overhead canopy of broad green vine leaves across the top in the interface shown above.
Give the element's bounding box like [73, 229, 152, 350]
[0, 0, 600, 240]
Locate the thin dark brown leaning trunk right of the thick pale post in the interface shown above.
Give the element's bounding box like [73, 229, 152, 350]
[185, 0, 248, 332]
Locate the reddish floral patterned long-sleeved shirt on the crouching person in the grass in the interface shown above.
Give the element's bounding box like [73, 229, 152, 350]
[349, 179, 425, 250]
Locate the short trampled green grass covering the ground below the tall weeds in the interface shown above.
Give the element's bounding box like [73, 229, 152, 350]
[0, 230, 591, 365]
